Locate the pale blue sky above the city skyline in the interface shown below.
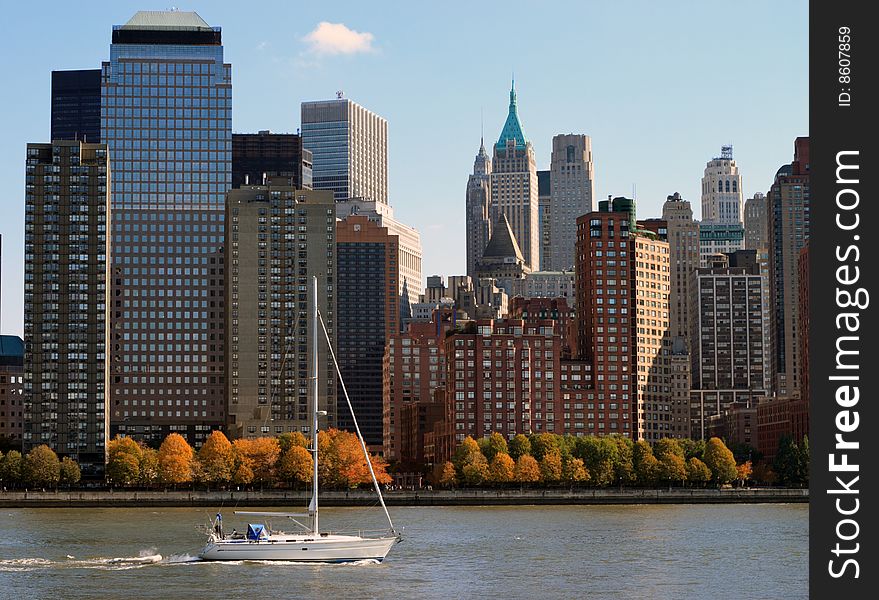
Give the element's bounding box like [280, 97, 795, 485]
[0, 0, 808, 335]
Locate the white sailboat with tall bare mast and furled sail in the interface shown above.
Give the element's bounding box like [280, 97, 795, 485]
[198, 277, 402, 563]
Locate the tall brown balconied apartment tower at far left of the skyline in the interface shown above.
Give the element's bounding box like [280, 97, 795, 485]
[22, 140, 110, 475]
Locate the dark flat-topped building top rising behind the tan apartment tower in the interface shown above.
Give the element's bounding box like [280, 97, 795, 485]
[232, 131, 311, 190]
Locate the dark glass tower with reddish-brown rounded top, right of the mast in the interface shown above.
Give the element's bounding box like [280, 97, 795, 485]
[336, 215, 400, 452]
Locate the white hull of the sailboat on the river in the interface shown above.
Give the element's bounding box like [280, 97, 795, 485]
[198, 535, 399, 563]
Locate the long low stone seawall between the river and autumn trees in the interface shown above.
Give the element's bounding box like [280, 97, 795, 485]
[0, 488, 809, 508]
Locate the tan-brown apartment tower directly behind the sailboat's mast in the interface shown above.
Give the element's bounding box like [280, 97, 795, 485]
[226, 185, 336, 438]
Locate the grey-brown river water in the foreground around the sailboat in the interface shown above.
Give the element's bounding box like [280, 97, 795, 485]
[0, 504, 809, 600]
